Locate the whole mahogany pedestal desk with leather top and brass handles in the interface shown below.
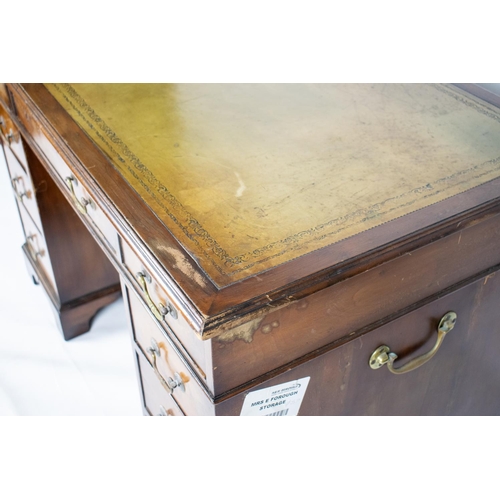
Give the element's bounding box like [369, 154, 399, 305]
[0, 84, 500, 416]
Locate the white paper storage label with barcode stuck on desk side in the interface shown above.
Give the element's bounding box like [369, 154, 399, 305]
[240, 377, 311, 417]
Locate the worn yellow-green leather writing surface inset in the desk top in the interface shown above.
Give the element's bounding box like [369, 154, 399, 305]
[46, 84, 500, 286]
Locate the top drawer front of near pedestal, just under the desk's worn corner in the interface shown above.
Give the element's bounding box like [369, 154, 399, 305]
[123, 242, 212, 387]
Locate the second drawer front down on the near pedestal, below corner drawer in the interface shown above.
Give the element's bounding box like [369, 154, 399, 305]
[125, 287, 213, 415]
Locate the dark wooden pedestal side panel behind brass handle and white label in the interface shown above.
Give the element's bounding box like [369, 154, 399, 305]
[217, 271, 500, 415]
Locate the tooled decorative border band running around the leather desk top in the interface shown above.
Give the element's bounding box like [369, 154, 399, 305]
[48, 84, 500, 277]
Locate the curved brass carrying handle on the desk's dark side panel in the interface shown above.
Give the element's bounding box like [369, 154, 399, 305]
[369, 311, 457, 375]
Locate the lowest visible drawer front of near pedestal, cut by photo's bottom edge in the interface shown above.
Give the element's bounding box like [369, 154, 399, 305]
[137, 353, 184, 417]
